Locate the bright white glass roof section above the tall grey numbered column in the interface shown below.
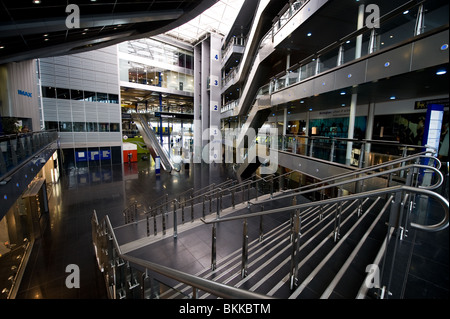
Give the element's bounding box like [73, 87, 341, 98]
[165, 0, 244, 44]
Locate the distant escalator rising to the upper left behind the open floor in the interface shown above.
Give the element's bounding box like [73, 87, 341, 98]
[132, 113, 181, 173]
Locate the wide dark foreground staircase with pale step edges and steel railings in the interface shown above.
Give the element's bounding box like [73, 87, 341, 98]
[93, 155, 448, 299]
